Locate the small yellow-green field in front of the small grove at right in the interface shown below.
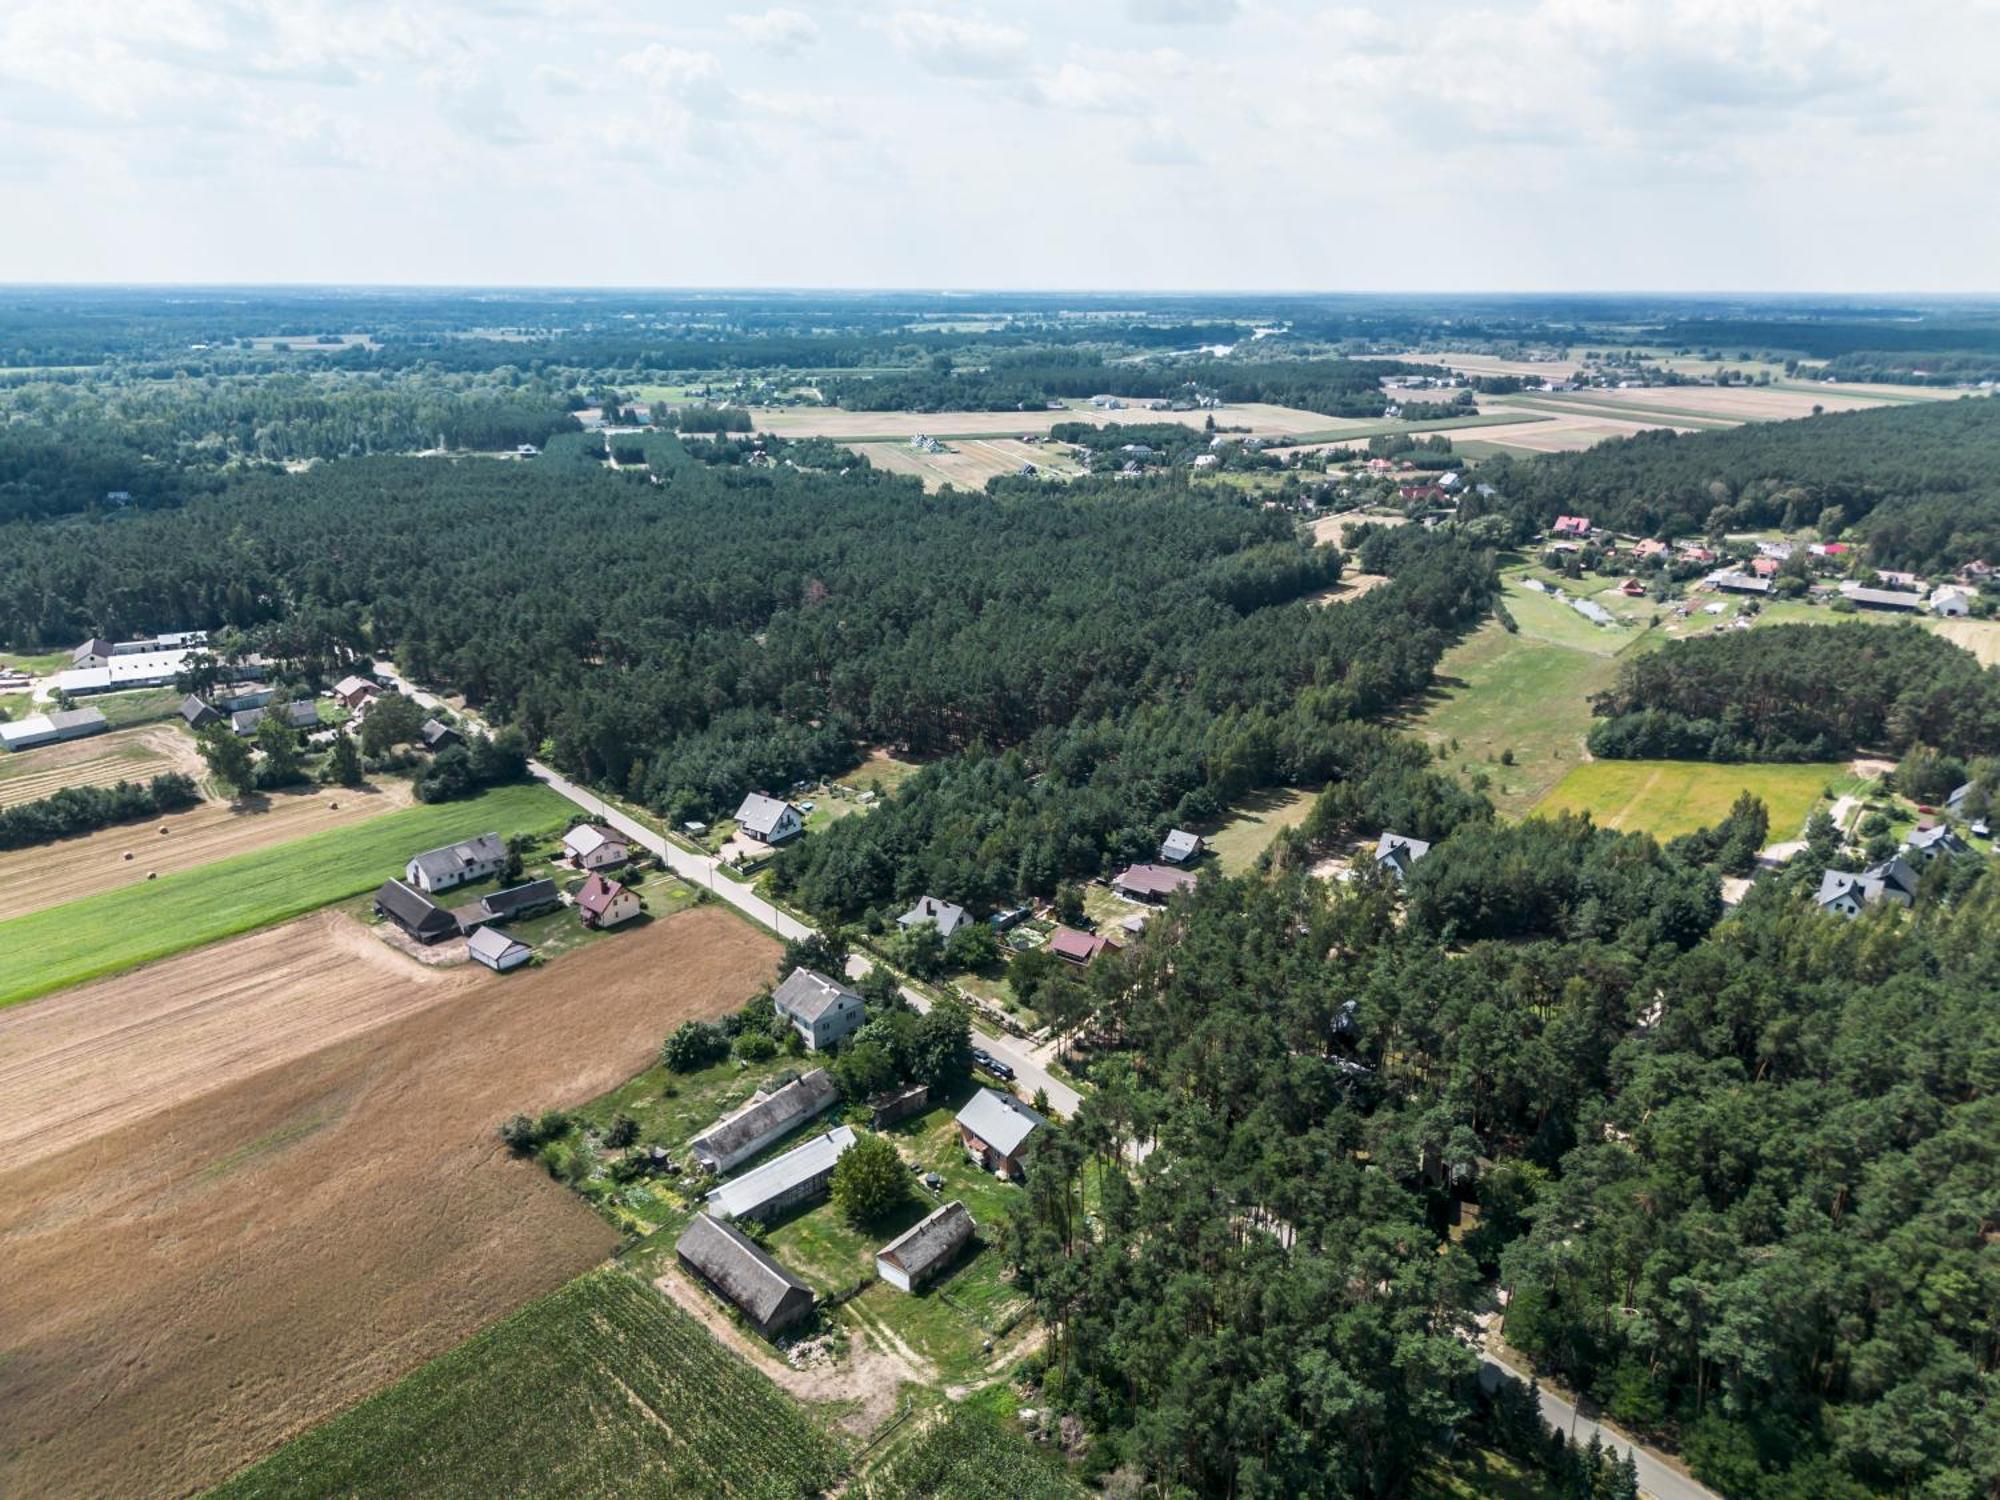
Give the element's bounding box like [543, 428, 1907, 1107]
[1536, 760, 1850, 840]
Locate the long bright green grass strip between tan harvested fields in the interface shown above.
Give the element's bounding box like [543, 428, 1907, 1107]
[0, 784, 570, 1006]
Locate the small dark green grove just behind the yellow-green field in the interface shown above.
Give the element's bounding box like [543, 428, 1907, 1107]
[1590, 624, 2000, 760]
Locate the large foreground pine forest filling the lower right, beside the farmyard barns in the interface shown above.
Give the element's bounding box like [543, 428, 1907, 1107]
[1010, 840, 2000, 1500]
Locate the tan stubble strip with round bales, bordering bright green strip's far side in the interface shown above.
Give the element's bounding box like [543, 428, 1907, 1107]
[0, 780, 410, 922]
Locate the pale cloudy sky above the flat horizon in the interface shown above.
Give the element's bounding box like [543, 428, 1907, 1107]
[0, 0, 2000, 292]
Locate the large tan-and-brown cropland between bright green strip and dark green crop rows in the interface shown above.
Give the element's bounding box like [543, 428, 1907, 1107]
[0, 906, 778, 1496]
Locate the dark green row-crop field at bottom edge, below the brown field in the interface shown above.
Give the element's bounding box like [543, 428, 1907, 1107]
[212, 1270, 840, 1500]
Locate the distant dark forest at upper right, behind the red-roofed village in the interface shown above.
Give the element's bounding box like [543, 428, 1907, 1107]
[1482, 398, 2000, 570]
